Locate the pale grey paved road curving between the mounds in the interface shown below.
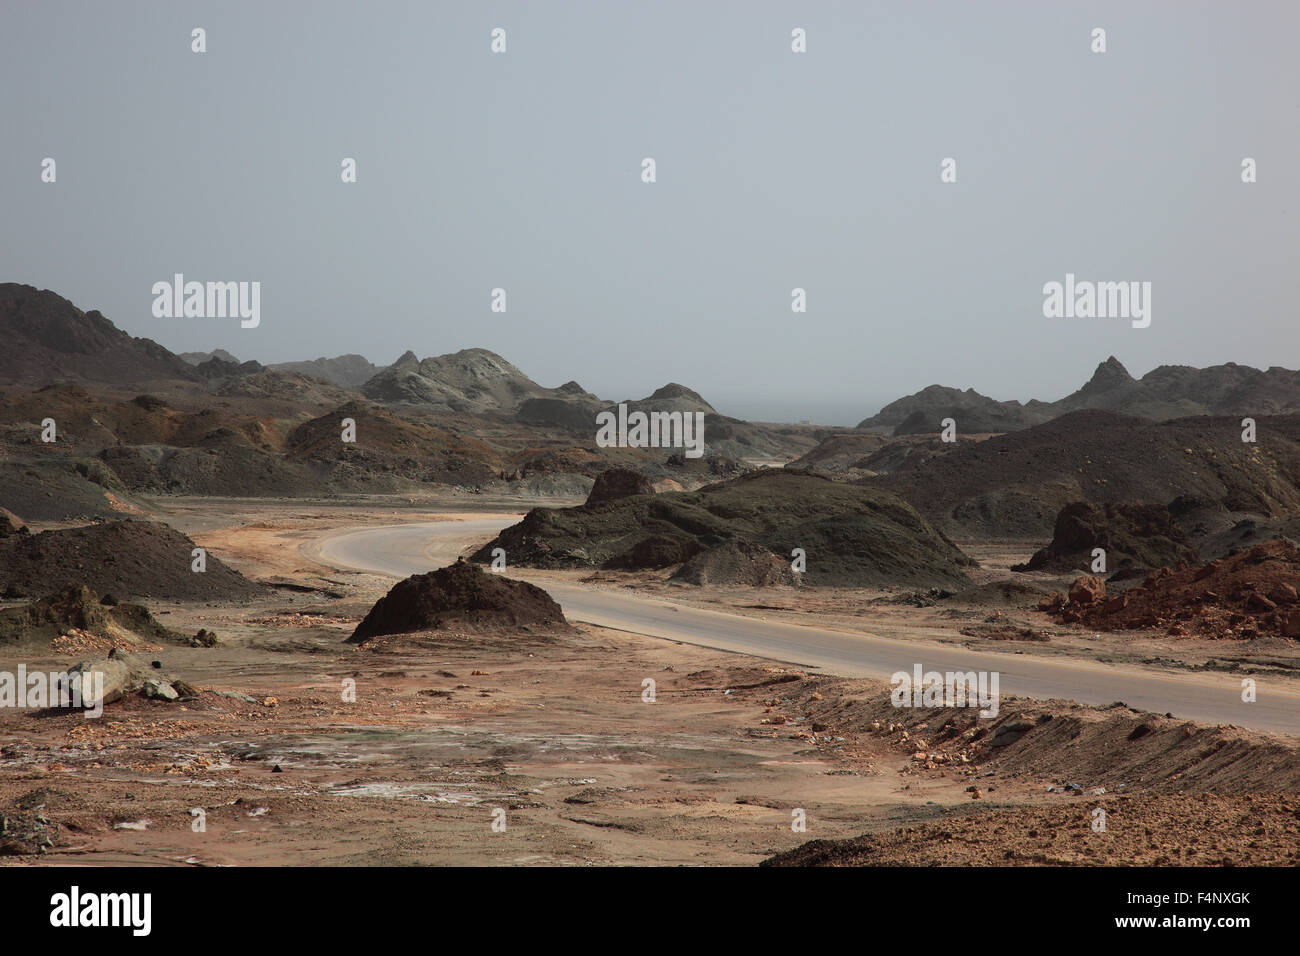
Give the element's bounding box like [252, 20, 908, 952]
[309, 515, 1300, 735]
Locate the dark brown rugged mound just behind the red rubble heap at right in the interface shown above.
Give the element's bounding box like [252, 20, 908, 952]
[1011, 501, 1197, 572]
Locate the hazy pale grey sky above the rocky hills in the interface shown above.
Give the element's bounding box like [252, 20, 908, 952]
[0, 0, 1300, 424]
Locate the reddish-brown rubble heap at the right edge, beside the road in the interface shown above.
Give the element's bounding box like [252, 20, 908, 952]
[1043, 538, 1300, 639]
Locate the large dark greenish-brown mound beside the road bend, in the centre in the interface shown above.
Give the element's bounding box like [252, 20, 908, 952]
[473, 470, 972, 588]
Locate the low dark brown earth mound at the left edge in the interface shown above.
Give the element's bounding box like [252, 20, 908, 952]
[0, 520, 263, 601]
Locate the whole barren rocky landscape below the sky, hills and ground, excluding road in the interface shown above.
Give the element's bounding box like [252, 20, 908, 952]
[0, 278, 1300, 865]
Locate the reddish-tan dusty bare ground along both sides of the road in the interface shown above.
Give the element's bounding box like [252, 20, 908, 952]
[0, 498, 1300, 866]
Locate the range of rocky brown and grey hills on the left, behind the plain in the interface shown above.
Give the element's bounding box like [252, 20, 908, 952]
[0, 284, 816, 520]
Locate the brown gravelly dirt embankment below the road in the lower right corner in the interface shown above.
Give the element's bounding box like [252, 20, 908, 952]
[764, 679, 1300, 866]
